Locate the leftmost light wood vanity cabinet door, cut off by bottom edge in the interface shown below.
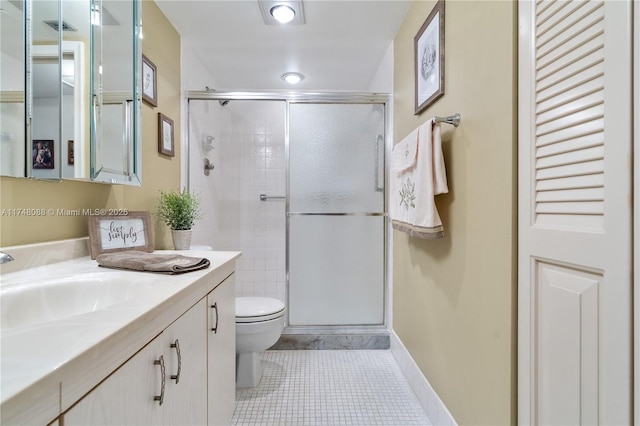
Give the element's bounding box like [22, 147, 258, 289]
[63, 339, 166, 426]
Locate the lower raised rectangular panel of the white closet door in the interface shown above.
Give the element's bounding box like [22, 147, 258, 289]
[534, 259, 603, 425]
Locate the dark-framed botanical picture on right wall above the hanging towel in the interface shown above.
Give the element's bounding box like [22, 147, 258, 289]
[413, 0, 444, 115]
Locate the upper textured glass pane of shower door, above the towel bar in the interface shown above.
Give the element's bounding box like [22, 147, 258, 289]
[289, 104, 384, 213]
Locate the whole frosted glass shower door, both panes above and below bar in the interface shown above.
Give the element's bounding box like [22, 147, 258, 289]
[287, 103, 385, 326]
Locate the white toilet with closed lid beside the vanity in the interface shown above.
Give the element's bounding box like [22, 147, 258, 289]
[236, 297, 285, 388]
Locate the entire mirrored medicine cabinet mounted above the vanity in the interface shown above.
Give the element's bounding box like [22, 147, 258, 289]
[0, 0, 142, 185]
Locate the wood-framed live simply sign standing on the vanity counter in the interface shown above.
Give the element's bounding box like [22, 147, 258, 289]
[89, 209, 153, 259]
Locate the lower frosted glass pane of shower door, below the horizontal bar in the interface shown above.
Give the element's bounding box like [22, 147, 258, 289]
[289, 215, 384, 325]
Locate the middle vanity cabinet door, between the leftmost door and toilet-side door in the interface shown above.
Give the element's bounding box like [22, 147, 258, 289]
[161, 298, 207, 425]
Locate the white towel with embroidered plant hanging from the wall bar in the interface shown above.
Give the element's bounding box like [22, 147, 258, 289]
[390, 119, 449, 239]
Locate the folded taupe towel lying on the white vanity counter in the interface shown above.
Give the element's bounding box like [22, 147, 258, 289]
[96, 250, 211, 274]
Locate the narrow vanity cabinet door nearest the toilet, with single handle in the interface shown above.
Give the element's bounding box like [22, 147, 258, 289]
[207, 274, 236, 426]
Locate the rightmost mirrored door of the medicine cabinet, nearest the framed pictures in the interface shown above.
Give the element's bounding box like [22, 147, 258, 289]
[91, 0, 142, 185]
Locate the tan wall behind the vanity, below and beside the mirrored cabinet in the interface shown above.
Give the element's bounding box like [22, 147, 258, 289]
[0, 0, 180, 248]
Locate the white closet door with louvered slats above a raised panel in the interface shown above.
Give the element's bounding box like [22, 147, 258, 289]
[518, 0, 632, 425]
